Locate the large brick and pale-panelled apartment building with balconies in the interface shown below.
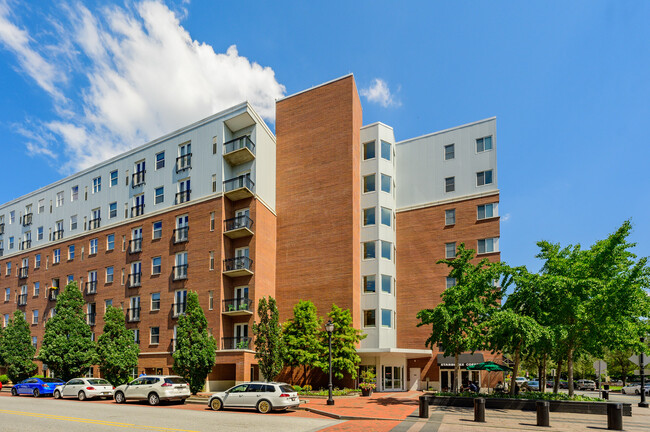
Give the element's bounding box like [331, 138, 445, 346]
[0, 75, 500, 391]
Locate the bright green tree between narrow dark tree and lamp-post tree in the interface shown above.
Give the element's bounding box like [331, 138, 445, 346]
[283, 300, 327, 381]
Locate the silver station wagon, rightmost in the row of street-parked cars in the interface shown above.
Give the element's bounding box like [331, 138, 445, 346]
[208, 381, 300, 414]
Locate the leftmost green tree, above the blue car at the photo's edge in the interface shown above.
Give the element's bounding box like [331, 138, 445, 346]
[0, 310, 36, 383]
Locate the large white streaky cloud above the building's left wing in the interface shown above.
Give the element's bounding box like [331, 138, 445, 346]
[0, 0, 285, 172]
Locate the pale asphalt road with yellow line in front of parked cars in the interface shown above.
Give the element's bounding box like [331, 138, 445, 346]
[0, 393, 340, 432]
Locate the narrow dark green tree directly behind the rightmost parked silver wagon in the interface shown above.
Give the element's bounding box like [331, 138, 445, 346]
[253, 296, 285, 381]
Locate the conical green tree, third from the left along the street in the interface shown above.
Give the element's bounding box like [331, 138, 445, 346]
[97, 306, 140, 386]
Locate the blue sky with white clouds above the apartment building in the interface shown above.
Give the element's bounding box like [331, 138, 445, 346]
[0, 0, 650, 270]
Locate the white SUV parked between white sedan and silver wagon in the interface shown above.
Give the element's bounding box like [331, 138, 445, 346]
[114, 375, 190, 405]
